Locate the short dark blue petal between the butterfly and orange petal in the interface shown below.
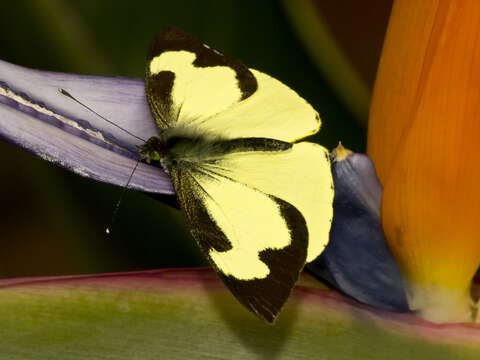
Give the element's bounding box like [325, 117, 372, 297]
[307, 146, 409, 312]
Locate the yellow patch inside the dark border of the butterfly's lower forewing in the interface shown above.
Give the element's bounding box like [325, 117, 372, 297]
[200, 175, 291, 280]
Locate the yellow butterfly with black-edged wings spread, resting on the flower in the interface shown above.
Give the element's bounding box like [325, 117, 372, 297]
[140, 26, 334, 323]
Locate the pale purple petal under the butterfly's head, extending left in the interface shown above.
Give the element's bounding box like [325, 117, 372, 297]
[0, 60, 173, 194]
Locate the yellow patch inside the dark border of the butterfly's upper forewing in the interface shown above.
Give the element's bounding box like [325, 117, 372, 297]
[150, 50, 242, 126]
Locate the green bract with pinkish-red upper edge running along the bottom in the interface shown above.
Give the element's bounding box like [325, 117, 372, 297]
[0, 269, 480, 360]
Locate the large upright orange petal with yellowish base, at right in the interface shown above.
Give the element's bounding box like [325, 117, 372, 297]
[368, 0, 480, 320]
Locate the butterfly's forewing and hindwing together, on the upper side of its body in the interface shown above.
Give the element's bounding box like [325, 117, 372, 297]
[146, 27, 320, 141]
